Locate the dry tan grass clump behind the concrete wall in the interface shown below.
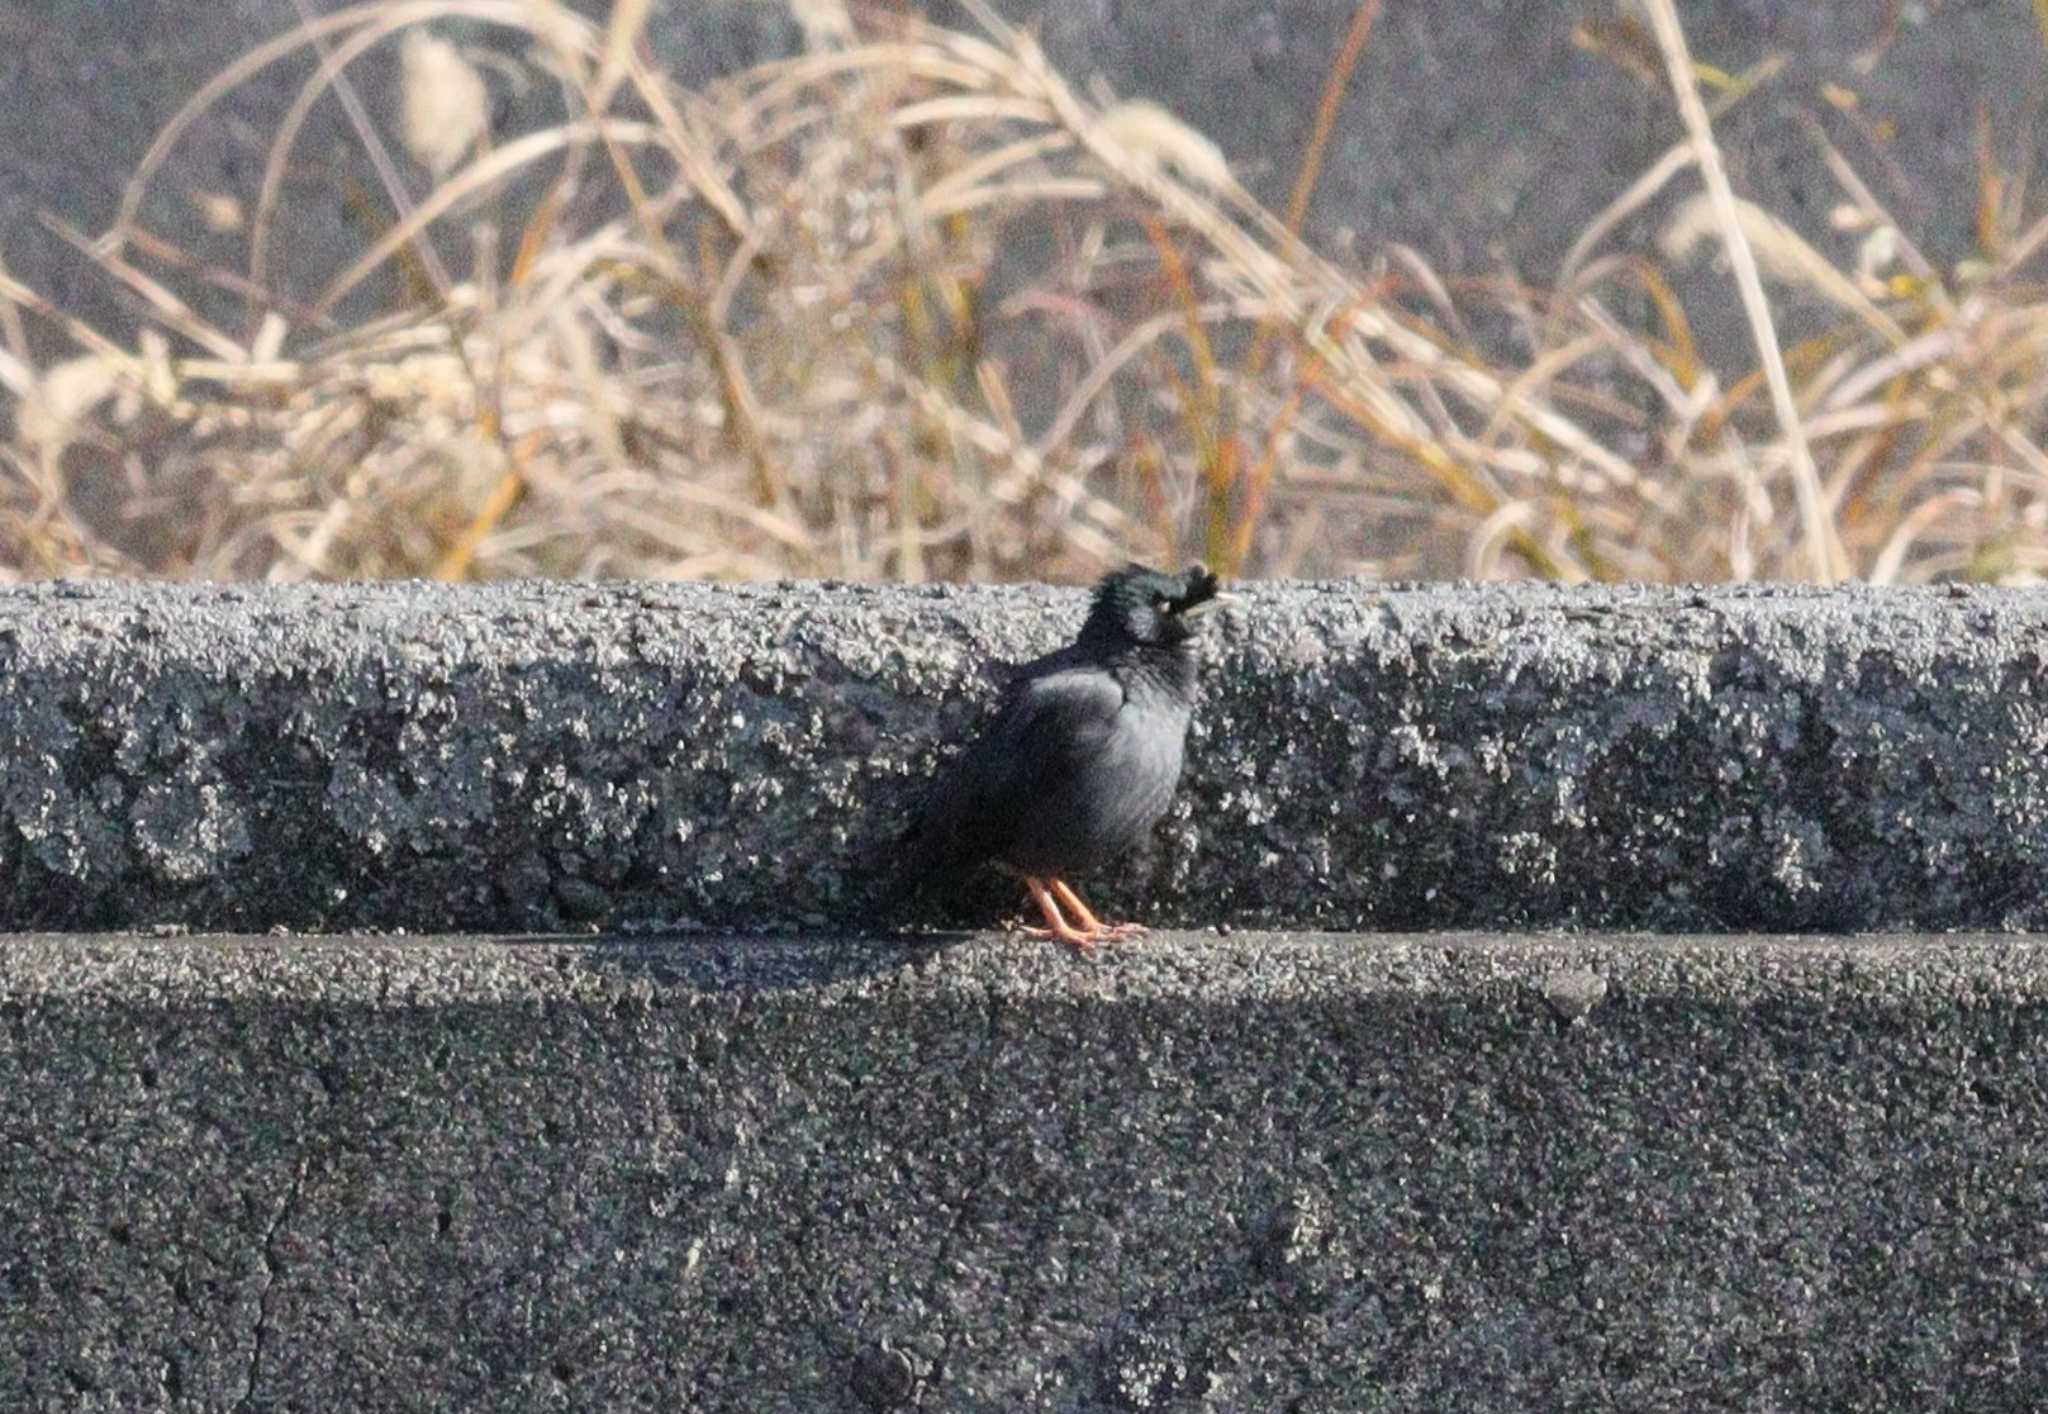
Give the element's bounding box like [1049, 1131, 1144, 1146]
[0, 0, 2048, 582]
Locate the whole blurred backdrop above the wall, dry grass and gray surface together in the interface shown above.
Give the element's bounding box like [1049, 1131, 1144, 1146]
[0, 0, 2048, 584]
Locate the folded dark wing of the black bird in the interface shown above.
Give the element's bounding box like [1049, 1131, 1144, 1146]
[905, 666, 1124, 877]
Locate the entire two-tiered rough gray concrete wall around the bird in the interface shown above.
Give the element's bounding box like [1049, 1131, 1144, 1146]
[12, 584, 2048, 1414]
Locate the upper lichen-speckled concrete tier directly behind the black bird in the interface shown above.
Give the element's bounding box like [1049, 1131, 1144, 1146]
[0, 584, 2048, 932]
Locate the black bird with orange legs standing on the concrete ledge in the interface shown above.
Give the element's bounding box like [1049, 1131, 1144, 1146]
[903, 564, 1227, 949]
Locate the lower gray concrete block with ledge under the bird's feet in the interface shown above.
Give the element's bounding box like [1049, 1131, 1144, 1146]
[0, 934, 2048, 1414]
